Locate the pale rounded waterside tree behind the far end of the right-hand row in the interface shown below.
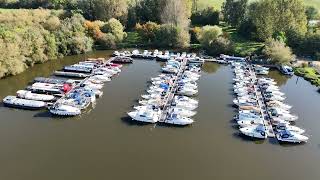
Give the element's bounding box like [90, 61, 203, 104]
[263, 39, 295, 64]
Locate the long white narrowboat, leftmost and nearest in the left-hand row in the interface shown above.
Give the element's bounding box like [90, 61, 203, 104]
[3, 96, 47, 110]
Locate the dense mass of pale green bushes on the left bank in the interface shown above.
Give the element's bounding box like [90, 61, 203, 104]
[0, 9, 93, 78]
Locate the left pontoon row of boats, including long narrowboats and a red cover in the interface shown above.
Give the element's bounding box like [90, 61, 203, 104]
[3, 59, 122, 116]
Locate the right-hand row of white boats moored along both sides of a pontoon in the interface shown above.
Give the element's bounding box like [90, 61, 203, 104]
[232, 62, 308, 143]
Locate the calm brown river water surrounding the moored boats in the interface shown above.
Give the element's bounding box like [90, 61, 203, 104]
[0, 51, 320, 180]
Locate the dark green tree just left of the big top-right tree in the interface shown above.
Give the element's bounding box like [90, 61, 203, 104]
[222, 0, 248, 27]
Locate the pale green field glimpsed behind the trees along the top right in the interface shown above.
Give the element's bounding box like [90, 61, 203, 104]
[198, 0, 320, 10]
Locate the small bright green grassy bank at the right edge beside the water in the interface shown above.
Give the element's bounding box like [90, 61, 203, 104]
[295, 67, 320, 87]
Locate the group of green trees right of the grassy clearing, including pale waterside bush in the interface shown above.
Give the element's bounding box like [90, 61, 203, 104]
[222, 0, 320, 63]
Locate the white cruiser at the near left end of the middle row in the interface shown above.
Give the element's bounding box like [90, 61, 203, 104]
[128, 109, 161, 123]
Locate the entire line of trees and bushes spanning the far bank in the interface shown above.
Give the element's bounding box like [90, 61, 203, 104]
[0, 0, 320, 78]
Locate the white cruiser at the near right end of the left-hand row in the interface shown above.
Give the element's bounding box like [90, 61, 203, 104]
[49, 104, 81, 116]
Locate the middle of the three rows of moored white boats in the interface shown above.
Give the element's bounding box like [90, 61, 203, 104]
[128, 59, 201, 126]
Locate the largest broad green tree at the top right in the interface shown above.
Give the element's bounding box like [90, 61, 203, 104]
[247, 0, 307, 40]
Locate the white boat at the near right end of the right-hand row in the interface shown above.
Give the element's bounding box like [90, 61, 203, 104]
[276, 130, 309, 143]
